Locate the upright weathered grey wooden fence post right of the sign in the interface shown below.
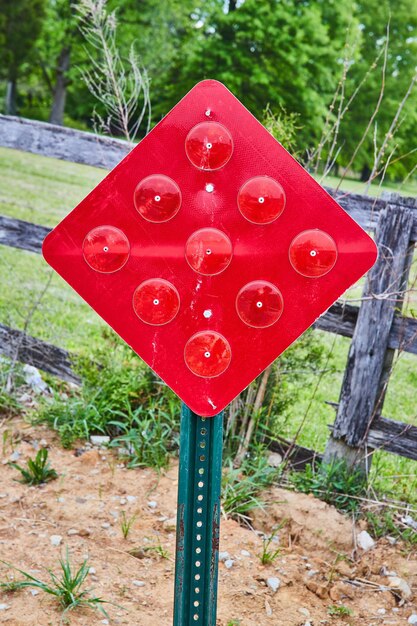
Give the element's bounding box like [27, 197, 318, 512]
[324, 204, 413, 469]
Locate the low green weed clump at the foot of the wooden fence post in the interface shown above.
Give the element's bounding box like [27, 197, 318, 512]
[289, 459, 366, 511]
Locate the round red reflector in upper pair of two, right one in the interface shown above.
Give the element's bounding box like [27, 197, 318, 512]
[237, 176, 285, 224]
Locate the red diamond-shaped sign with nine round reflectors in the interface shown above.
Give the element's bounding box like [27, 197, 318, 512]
[43, 80, 377, 416]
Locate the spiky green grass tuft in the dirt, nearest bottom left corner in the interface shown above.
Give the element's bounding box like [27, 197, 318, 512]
[0, 550, 108, 618]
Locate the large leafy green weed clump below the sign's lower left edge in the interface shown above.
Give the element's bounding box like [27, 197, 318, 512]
[37, 333, 178, 450]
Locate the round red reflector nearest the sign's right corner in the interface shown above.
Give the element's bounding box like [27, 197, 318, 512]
[289, 229, 337, 278]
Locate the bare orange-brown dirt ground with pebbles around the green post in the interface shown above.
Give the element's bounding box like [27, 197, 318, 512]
[0, 420, 417, 626]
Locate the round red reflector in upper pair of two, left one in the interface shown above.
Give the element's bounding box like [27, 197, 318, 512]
[133, 174, 181, 224]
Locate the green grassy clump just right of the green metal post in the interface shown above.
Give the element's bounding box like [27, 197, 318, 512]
[221, 446, 280, 523]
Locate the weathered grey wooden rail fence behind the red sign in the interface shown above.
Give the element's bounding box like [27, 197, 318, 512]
[0, 115, 417, 464]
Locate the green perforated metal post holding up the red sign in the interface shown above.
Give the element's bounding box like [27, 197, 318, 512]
[174, 405, 223, 626]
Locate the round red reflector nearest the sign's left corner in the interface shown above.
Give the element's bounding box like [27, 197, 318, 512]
[83, 226, 130, 274]
